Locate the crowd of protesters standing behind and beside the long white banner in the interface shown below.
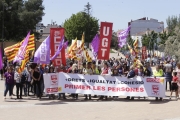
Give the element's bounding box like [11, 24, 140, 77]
[1, 54, 180, 100]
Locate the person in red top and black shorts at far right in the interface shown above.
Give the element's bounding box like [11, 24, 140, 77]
[169, 72, 179, 100]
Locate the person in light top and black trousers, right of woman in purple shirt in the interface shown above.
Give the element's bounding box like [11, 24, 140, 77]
[14, 66, 23, 99]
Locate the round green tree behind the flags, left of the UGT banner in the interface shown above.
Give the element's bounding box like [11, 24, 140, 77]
[64, 12, 99, 43]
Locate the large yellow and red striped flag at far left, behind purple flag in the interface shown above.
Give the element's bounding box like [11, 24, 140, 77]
[4, 34, 35, 62]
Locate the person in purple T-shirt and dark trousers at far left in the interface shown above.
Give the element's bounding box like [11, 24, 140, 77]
[4, 67, 14, 99]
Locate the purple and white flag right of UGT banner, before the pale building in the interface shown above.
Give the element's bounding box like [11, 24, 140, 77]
[118, 25, 131, 48]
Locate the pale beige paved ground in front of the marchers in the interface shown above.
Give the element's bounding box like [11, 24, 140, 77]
[0, 80, 180, 120]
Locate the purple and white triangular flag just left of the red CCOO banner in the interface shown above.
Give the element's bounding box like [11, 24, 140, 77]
[34, 36, 50, 64]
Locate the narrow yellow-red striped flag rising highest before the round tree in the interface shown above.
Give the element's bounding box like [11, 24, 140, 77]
[72, 33, 84, 60]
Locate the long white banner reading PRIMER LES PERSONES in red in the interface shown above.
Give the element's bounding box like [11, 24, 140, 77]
[43, 73, 166, 97]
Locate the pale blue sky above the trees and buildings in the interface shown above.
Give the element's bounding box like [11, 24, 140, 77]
[42, 0, 180, 31]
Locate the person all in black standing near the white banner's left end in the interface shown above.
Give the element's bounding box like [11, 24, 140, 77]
[31, 63, 41, 99]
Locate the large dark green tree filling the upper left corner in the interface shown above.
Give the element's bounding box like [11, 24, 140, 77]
[0, 0, 44, 41]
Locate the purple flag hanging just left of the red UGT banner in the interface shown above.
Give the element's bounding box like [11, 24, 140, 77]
[91, 34, 99, 60]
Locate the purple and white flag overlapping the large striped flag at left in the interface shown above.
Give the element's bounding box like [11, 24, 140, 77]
[13, 31, 31, 64]
